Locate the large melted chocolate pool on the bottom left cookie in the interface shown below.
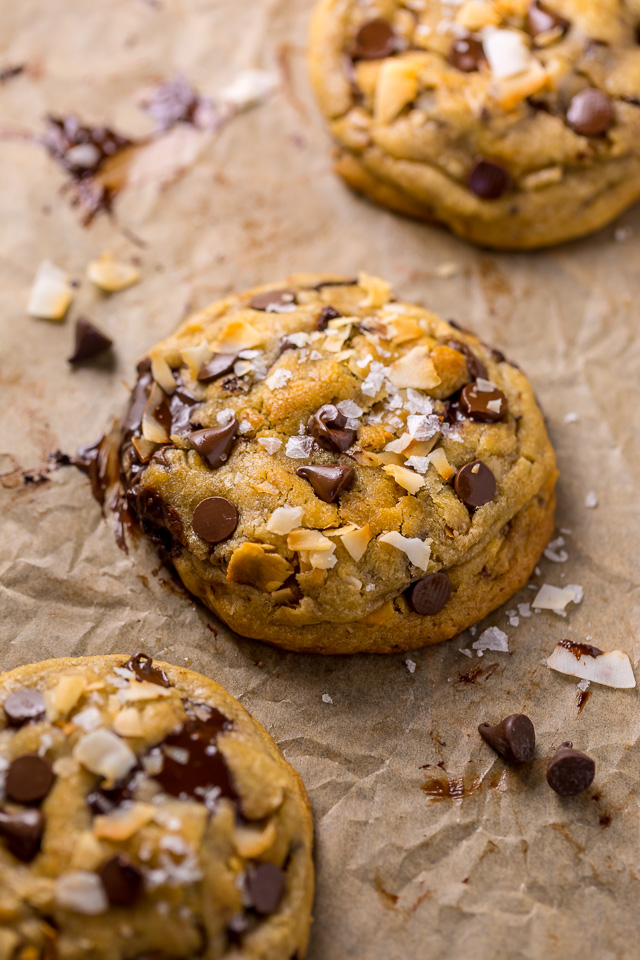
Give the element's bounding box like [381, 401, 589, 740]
[155, 705, 236, 805]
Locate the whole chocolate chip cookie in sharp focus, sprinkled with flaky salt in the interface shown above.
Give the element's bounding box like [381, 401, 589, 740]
[120, 274, 556, 653]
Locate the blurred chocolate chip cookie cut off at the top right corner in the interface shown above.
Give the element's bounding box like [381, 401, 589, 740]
[310, 0, 640, 250]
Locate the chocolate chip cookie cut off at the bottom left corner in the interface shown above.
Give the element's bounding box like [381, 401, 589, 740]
[0, 654, 313, 960]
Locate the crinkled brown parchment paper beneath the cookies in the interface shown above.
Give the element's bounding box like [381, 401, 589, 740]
[0, 0, 640, 960]
